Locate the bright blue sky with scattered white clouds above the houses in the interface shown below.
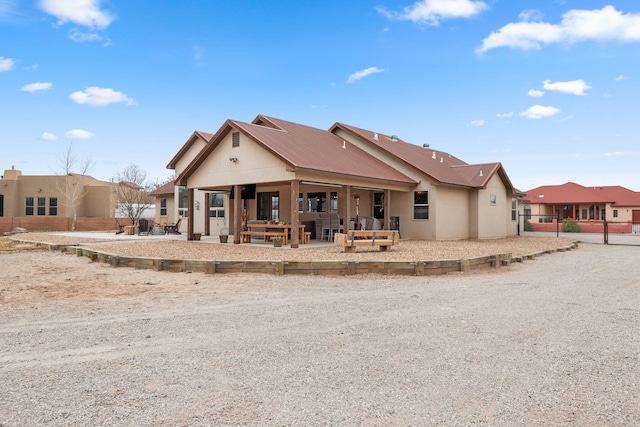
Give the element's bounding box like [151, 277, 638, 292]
[0, 0, 640, 191]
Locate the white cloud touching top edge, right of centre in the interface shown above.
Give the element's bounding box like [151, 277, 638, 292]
[377, 0, 488, 26]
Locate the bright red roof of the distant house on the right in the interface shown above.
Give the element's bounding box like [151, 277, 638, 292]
[526, 182, 640, 206]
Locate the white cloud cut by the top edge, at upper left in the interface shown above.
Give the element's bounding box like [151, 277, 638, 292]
[40, 0, 114, 28]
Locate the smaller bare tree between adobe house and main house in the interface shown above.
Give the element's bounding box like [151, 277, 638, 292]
[116, 164, 153, 225]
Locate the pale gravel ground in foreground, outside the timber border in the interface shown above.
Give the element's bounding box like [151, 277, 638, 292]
[0, 236, 640, 427]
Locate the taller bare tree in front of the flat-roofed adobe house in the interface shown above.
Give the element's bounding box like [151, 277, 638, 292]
[56, 143, 95, 231]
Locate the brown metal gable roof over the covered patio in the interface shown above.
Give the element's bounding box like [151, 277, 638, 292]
[176, 115, 417, 185]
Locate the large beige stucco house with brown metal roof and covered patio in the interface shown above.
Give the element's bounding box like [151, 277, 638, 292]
[166, 115, 519, 247]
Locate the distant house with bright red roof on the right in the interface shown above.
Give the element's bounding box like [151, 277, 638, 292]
[523, 182, 640, 232]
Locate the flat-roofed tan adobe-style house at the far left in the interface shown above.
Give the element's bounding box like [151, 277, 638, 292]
[0, 166, 117, 231]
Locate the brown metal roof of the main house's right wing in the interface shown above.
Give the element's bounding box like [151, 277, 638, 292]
[329, 122, 516, 192]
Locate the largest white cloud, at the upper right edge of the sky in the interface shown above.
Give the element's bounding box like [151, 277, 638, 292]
[478, 6, 640, 53]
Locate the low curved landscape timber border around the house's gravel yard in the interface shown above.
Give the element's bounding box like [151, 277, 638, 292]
[18, 241, 579, 276]
